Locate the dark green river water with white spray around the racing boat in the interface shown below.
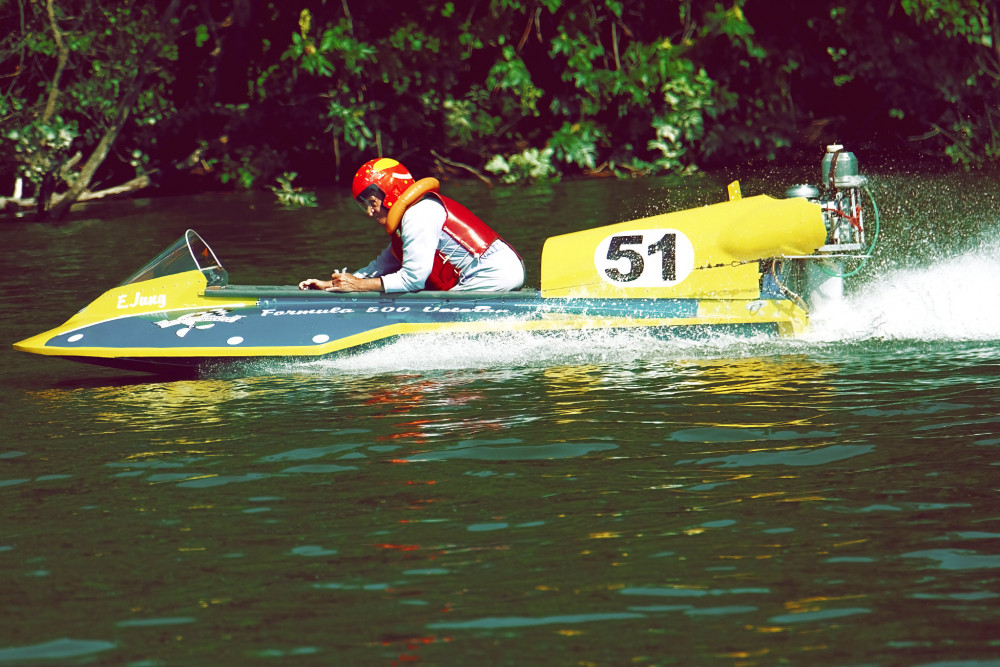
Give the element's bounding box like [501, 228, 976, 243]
[0, 156, 1000, 667]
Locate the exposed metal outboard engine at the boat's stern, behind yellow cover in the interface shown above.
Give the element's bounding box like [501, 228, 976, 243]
[787, 144, 878, 315]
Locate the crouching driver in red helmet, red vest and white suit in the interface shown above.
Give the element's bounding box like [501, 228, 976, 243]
[299, 158, 524, 292]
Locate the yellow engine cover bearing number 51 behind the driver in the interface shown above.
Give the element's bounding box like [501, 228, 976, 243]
[541, 195, 826, 299]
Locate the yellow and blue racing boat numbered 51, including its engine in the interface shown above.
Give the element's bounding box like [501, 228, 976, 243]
[14, 146, 878, 375]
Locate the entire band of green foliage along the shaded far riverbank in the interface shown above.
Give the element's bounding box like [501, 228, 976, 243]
[0, 0, 1000, 207]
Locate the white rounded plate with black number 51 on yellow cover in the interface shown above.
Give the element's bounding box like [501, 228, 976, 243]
[594, 229, 694, 287]
